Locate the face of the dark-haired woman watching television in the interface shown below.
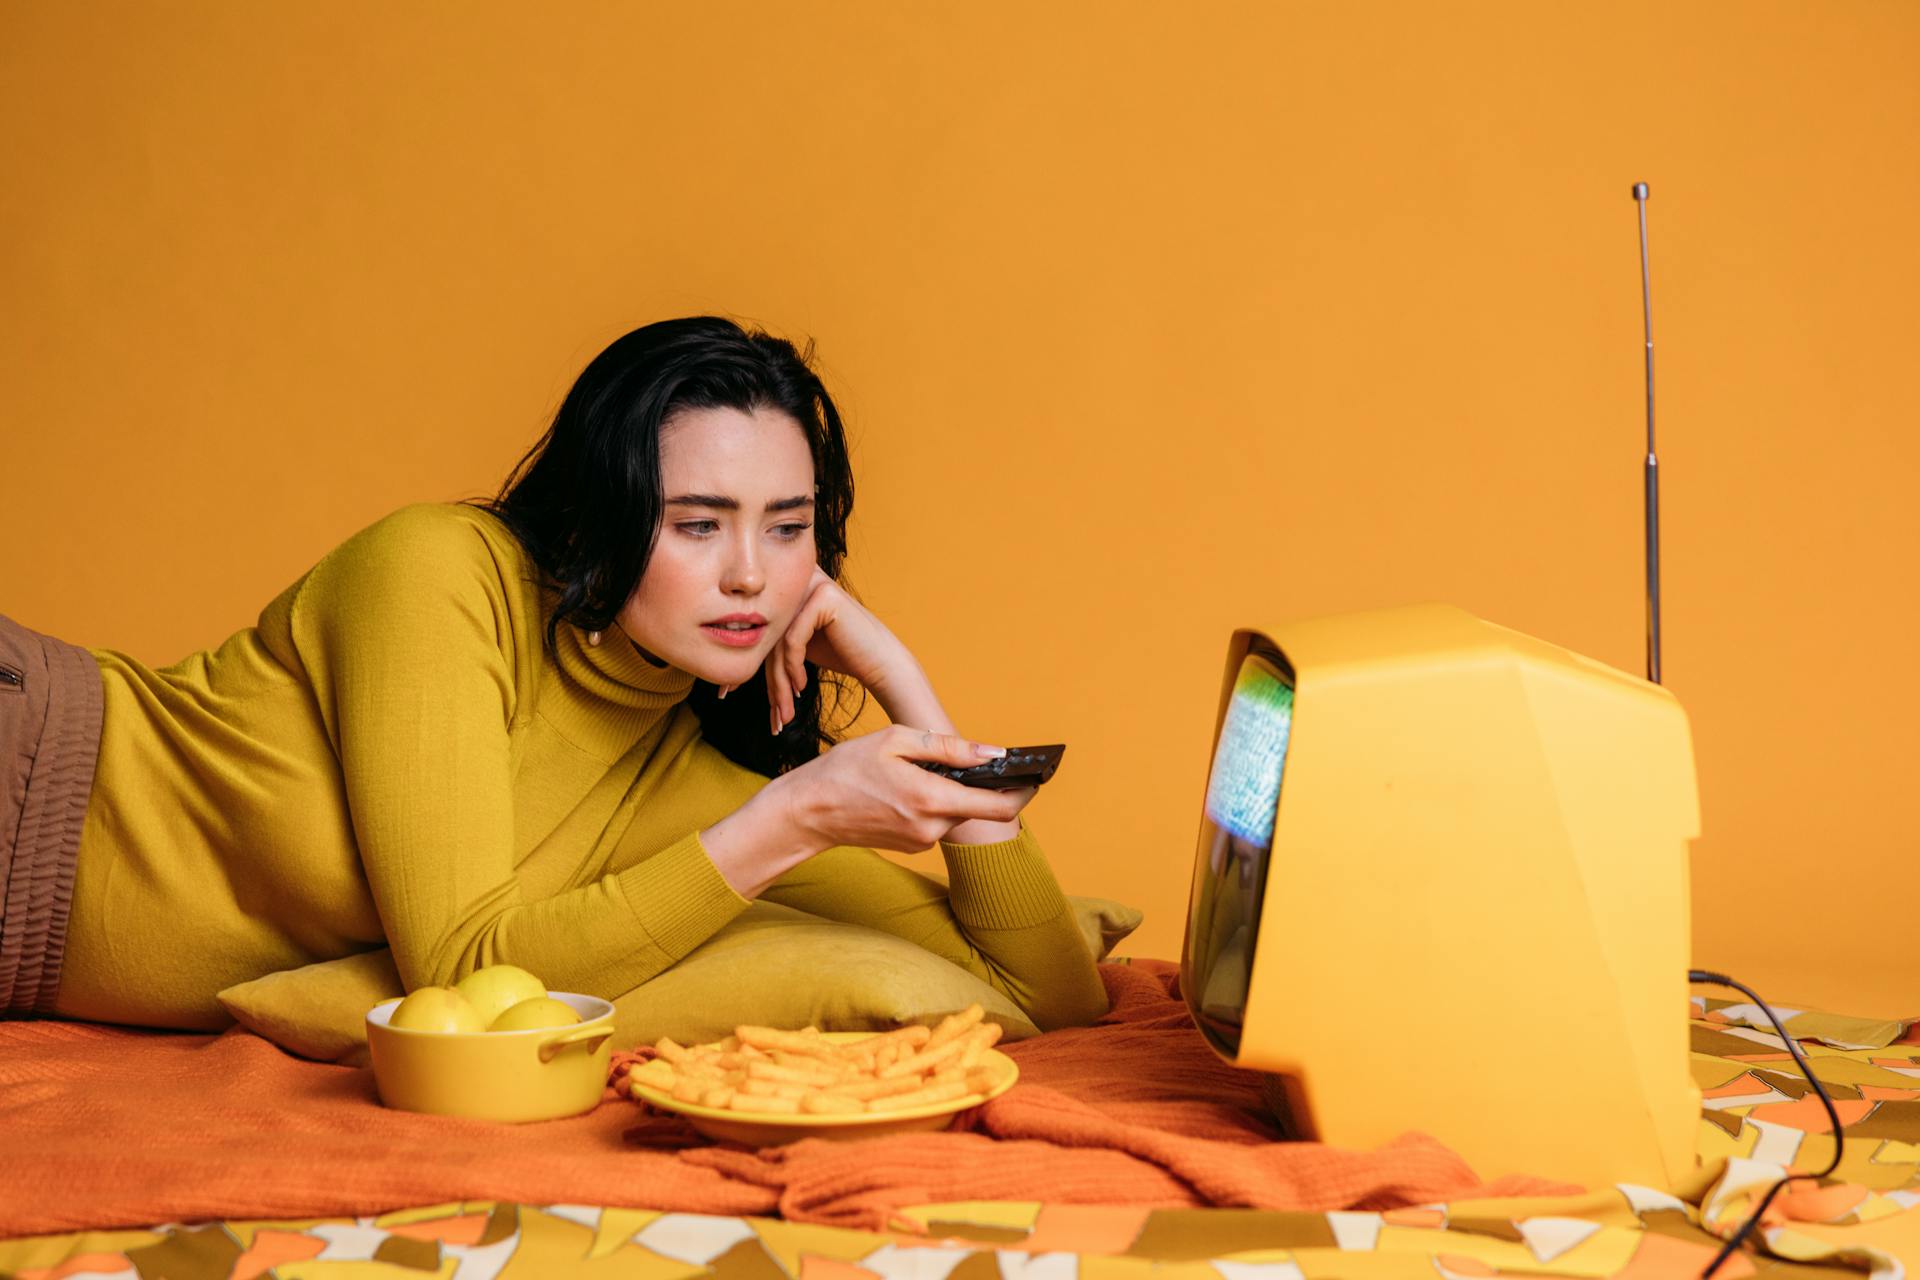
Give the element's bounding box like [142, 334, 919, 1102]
[618, 409, 814, 685]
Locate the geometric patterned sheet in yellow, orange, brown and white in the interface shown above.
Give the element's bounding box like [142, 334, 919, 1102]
[0, 998, 1920, 1280]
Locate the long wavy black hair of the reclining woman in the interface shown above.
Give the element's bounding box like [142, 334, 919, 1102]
[472, 315, 864, 777]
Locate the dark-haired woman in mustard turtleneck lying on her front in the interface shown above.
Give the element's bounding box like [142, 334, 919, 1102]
[0, 317, 1106, 1029]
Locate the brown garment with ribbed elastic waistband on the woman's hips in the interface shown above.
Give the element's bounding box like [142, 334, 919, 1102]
[0, 614, 102, 1017]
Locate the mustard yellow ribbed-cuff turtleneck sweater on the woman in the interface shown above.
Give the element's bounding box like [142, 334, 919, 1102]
[56, 505, 1106, 1029]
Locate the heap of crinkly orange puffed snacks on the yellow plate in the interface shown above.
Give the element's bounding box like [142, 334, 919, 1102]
[628, 1004, 1000, 1115]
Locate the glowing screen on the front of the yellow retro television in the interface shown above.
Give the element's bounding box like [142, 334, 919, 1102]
[1183, 639, 1294, 1057]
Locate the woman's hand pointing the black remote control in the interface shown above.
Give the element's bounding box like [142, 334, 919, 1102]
[776, 725, 1035, 854]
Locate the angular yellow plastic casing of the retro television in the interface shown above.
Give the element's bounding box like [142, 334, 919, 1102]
[1183, 604, 1699, 1190]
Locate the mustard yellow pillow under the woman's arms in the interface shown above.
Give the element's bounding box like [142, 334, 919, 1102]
[219, 898, 1140, 1065]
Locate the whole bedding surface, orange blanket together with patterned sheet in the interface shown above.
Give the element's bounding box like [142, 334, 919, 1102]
[0, 960, 1920, 1280]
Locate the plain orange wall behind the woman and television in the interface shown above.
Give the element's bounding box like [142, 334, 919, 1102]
[0, 0, 1920, 1015]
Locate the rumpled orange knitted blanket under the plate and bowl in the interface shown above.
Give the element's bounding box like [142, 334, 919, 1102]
[0, 960, 1576, 1236]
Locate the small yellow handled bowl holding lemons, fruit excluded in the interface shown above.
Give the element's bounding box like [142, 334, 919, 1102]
[367, 990, 612, 1121]
